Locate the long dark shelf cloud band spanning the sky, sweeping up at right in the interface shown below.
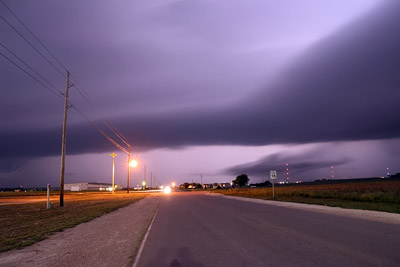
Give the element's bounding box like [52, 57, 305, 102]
[0, 1, 400, 163]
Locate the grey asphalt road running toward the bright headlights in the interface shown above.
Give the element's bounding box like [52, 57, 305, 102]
[137, 192, 400, 267]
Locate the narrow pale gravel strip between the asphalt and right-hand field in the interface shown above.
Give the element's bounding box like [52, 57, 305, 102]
[210, 193, 400, 225]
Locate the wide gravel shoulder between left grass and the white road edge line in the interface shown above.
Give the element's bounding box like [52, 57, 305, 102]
[0, 195, 161, 267]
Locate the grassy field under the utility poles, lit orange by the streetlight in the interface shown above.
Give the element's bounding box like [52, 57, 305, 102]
[0, 192, 145, 252]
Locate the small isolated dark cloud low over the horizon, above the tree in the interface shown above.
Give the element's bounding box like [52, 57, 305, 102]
[224, 153, 350, 180]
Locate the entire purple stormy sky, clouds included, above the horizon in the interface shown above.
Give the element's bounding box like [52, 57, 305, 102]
[0, 0, 400, 187]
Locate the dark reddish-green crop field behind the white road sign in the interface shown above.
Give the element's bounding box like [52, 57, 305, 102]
[215, 179, 400, 216]
